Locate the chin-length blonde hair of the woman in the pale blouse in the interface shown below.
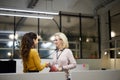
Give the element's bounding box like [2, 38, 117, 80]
[54, 32, 69, 48]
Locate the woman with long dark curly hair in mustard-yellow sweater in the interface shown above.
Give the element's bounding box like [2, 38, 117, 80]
[21, 32, 47, 72]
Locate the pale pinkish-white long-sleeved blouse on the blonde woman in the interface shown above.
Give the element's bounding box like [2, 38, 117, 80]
[50, 49, 76, 78]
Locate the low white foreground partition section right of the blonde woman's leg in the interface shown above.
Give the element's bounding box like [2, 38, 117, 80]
[71, 70, 120, 80]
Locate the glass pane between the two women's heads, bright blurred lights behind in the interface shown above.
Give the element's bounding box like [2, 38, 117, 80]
[39, 17, 59, 58]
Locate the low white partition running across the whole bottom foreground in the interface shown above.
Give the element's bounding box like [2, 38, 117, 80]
[0, 70, 120, 80]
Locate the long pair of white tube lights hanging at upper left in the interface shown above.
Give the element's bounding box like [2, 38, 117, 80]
[0, 8, 58, 19]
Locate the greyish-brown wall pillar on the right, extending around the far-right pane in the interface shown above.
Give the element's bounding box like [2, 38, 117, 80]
[97, 0, 120, 69]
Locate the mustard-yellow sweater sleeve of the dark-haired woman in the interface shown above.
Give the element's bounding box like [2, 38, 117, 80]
[33, 49, 46, 71]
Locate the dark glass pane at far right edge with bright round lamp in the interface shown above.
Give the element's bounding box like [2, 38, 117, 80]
[107, 4, 120, 58]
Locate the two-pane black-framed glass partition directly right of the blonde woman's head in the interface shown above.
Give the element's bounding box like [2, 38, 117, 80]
[61, 14, 100, 59]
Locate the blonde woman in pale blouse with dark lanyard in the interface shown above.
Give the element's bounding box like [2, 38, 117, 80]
[50, 32, 76, 80]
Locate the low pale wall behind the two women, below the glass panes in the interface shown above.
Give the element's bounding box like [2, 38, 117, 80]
[0, 59, 120, 73]
